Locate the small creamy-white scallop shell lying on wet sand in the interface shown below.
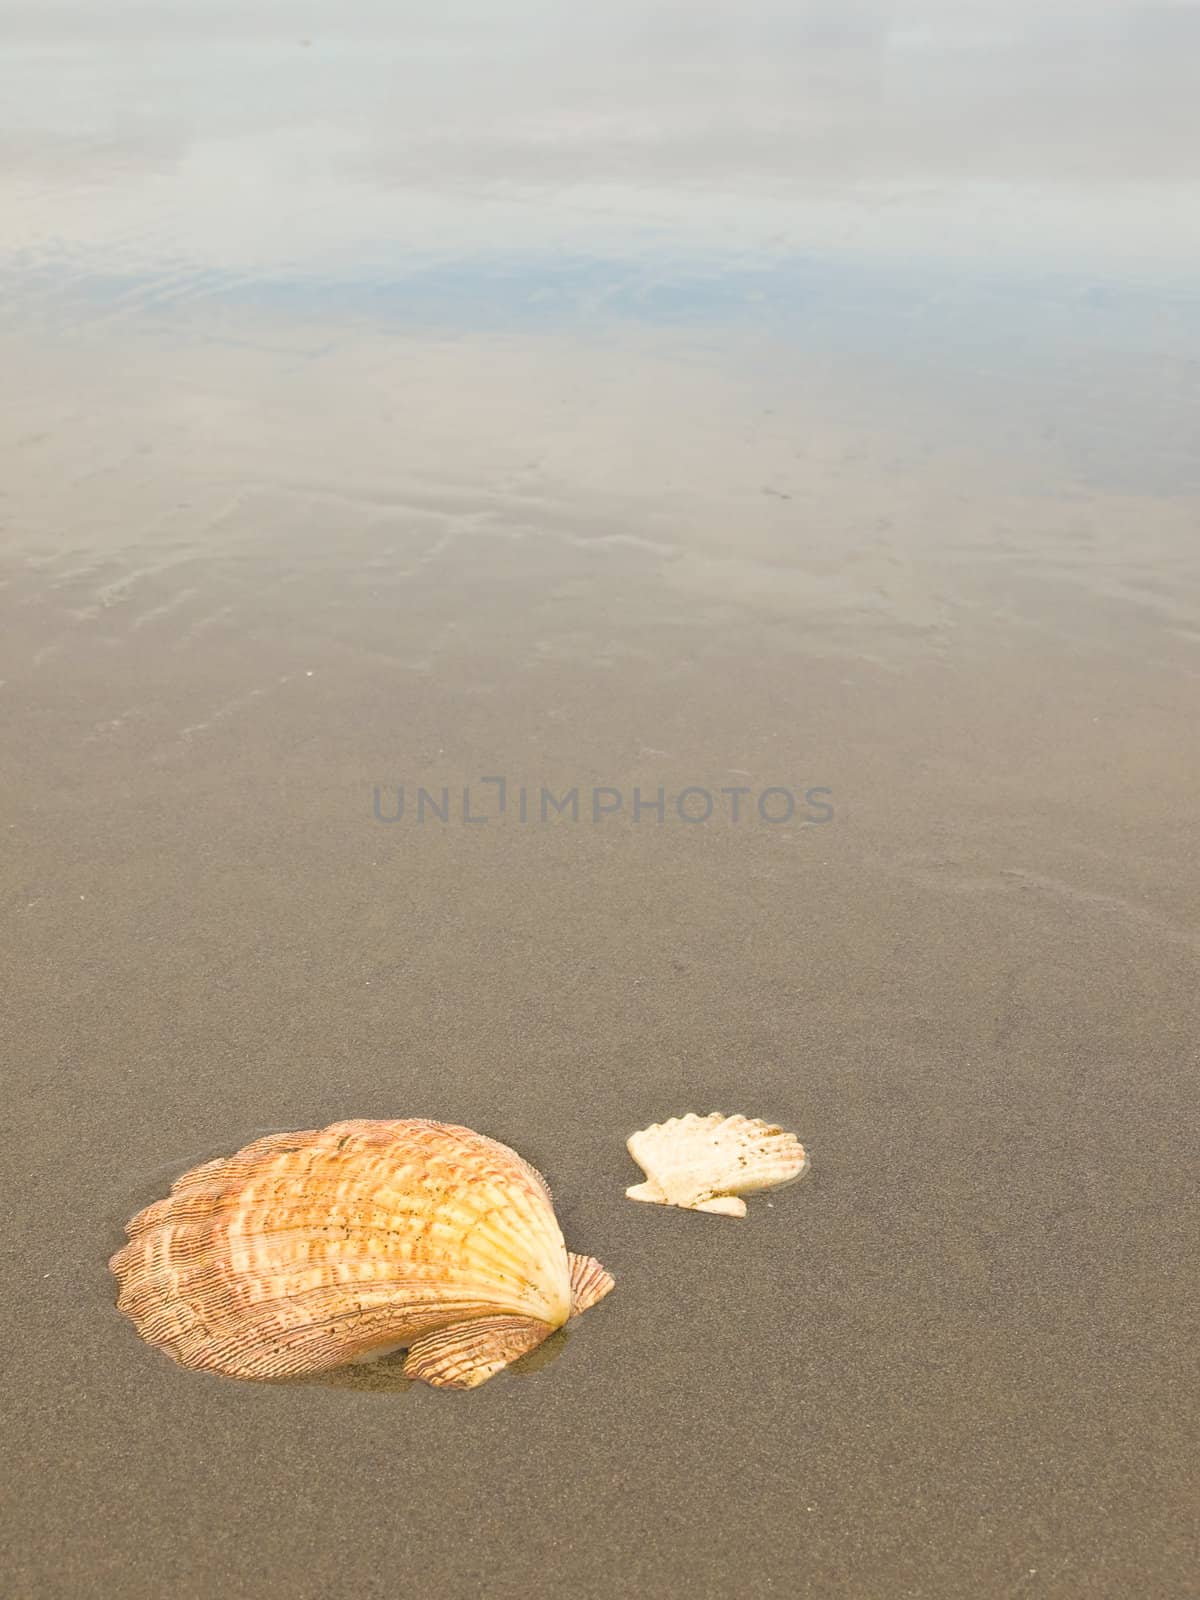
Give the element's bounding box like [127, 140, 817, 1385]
[626, 1110, 808, 1216]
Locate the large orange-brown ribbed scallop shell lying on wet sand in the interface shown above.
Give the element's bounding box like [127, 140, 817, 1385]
[109, 1118, 613, 1389]
